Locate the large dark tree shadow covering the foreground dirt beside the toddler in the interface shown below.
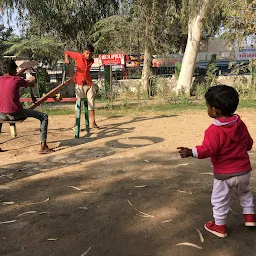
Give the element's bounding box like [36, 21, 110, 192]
[0, 150, 256, 256]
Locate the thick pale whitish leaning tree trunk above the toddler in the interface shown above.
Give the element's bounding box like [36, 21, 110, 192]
[176, 0, 209, 96]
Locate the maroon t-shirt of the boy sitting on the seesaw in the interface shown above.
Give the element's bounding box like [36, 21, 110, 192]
[0, 76, 28, 114]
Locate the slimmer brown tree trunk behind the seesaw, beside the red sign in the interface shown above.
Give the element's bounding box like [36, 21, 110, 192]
[141, 45, 152, 93]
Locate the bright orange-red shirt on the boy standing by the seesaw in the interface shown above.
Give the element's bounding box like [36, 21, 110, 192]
[65, 51, 94, 86]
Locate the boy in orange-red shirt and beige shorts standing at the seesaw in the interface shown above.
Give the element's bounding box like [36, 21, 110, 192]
[64, 44, 99, 128]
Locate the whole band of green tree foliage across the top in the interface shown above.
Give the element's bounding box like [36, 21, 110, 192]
[0, 0, 256, 52]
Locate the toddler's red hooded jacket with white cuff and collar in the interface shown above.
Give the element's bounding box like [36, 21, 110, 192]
[192, 115, 253, 174]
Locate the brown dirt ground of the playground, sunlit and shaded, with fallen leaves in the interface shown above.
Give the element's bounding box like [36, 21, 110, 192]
[0, 110, 256, 256]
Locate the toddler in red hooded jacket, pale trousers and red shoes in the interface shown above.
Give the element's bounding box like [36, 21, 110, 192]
[178, 85, 256, 237]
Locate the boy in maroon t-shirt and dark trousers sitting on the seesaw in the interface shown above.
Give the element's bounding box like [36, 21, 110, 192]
[0, 59, 53, 154]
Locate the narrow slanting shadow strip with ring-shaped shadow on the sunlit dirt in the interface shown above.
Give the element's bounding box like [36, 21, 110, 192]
[0, 136, 164, 179]
